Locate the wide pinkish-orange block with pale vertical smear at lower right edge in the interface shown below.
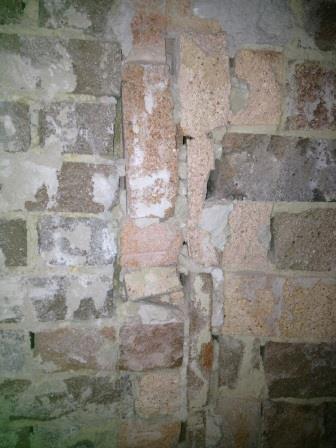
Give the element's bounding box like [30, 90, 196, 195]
[223, 273, 336, 342]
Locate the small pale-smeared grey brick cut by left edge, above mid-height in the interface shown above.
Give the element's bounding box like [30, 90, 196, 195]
[0, 101, 31, 152]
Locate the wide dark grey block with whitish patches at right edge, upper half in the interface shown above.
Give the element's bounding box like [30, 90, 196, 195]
[209, 134, 336, 202]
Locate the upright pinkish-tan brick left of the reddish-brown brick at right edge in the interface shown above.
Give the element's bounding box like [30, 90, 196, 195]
[231, 50, 283, 126]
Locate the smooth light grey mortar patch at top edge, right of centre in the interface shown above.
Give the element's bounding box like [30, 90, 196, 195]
[192, 0, 296, 56]
